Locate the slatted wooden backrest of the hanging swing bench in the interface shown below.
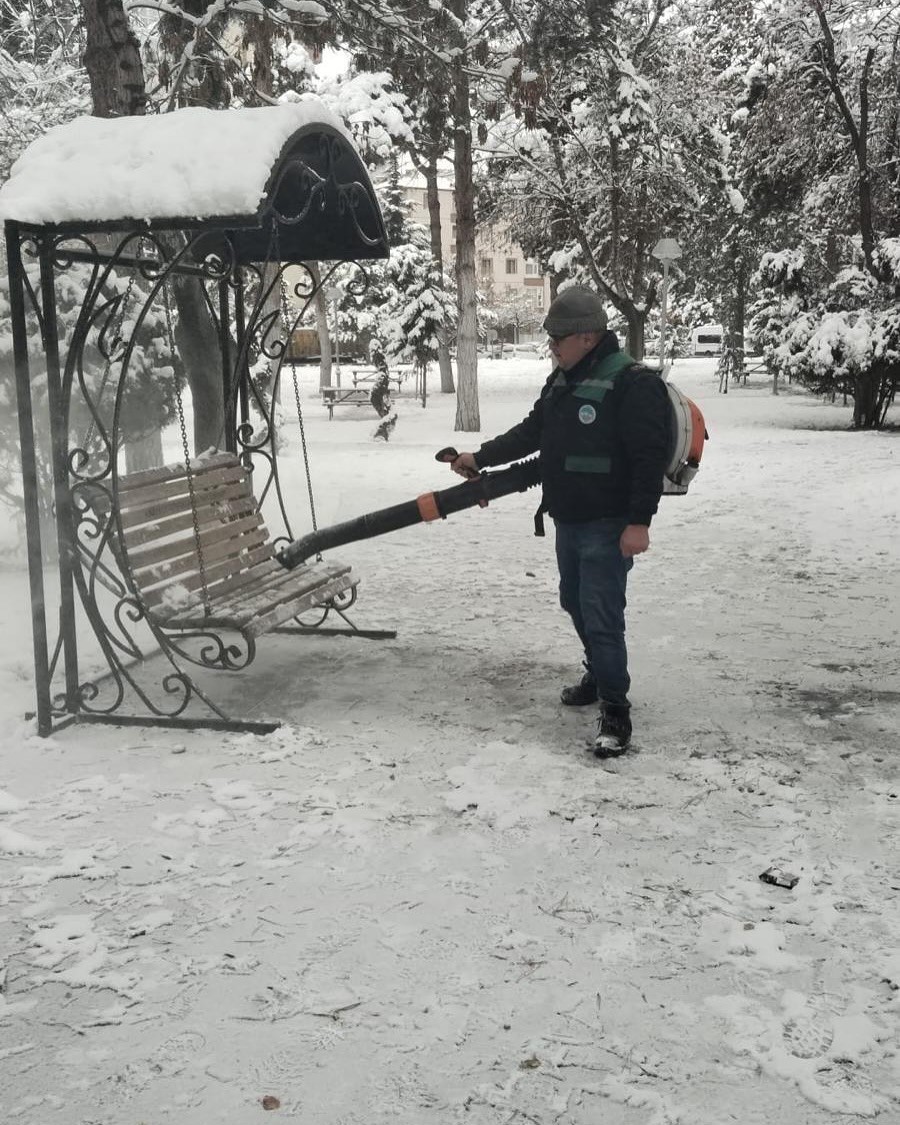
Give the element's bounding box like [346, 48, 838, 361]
[110, 453, 271, 617]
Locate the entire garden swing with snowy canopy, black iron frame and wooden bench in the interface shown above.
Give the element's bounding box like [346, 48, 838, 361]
[0, 100, 395, 735]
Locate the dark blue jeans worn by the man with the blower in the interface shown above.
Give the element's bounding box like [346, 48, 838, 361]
[556, 519, 633, 707]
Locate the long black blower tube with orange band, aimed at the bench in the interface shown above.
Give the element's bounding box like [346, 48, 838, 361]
[276, 457, 540, 570]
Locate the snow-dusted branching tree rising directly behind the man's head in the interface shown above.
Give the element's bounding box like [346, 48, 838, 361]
[484, 0, 692, 357]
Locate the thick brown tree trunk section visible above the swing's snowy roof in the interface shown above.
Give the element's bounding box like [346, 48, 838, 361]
[82, 0, 147, 117]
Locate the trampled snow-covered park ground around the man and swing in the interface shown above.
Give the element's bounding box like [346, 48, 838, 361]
[0, 358, 900, 1125]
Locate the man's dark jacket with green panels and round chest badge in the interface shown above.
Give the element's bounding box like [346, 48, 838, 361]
[475, 332, 672, 527]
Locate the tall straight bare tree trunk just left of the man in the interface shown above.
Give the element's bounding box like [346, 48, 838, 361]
[452, 26, 482, 432]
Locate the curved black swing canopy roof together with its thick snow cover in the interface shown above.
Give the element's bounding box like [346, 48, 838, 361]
[0, 98, 388, 262]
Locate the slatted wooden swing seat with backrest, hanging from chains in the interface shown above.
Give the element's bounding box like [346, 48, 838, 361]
[108, 453, 358, 639]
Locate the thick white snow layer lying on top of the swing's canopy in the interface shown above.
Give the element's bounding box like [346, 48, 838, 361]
[0, 97, 352, 223]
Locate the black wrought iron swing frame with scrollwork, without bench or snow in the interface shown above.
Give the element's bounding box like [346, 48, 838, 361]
[6, 123, 394, 735]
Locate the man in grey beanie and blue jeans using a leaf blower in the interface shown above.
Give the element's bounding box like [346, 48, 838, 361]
[450, 286, 671, 757]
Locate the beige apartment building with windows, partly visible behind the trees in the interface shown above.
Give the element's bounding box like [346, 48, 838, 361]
[402, 179, 550, 343]
